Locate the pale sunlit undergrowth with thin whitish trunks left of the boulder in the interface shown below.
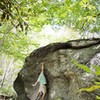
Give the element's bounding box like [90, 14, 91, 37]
[0, 54, 23, 96]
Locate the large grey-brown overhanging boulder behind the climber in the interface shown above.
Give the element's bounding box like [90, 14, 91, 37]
[14, 39, 100, 100]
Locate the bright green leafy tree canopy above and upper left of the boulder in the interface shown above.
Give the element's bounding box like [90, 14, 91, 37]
[0, 0, 100, 60]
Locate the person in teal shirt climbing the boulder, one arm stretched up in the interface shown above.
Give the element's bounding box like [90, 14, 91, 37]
[32, 63, 47, 100]
